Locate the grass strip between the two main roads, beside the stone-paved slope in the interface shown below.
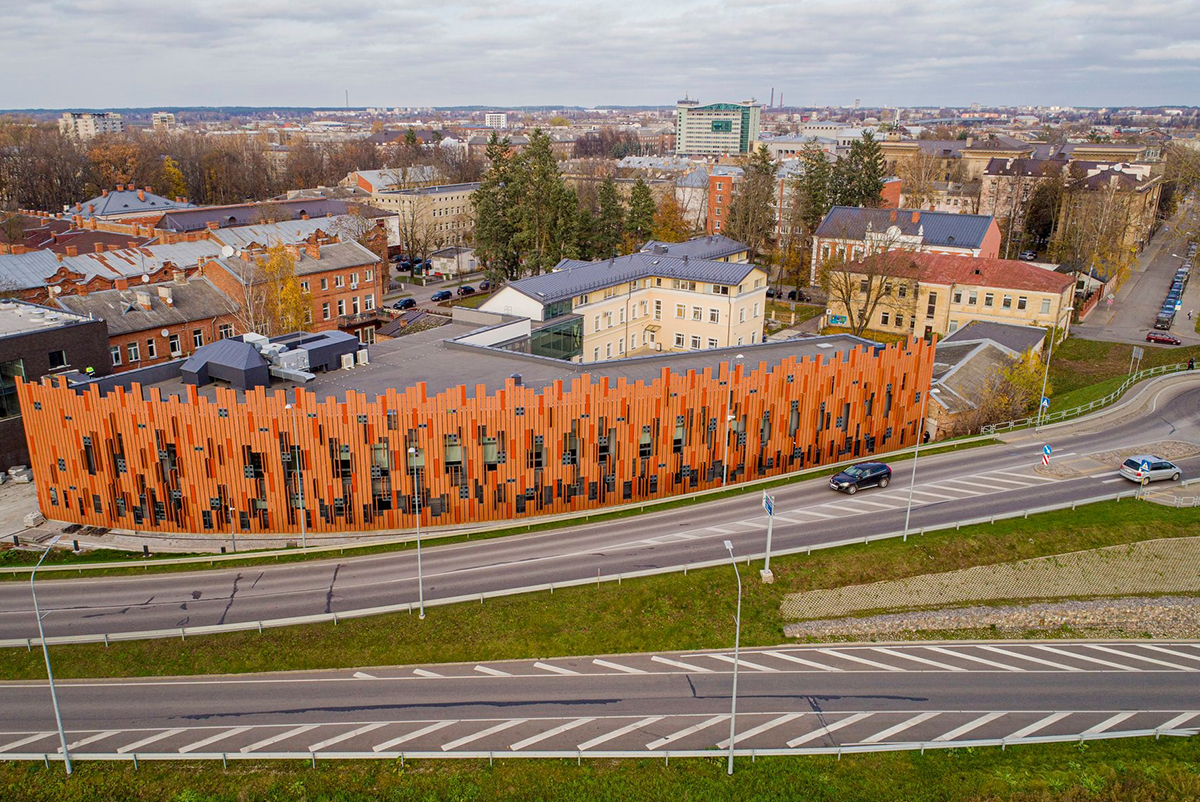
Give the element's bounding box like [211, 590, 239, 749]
[0, 501, 1200, 680]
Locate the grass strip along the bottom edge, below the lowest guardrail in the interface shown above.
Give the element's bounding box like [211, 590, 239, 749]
[0, 737, 1200, 802]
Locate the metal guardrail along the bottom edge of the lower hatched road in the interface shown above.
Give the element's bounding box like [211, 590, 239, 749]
[0, 729, 1200, 767]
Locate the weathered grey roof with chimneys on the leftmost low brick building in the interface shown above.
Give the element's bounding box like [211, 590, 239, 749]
[54, 277, 236, 336]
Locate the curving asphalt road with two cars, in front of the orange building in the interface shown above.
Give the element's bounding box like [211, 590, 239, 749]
[7, 382, 1200, 639]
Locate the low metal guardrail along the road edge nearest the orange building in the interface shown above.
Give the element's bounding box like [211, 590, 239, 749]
[0, 435, 992, 575]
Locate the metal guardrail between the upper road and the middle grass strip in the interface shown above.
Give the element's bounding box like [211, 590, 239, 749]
[0, 487, 1141, 651]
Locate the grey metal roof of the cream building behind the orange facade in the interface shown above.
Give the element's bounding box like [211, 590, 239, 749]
[509, 253, 757, 304]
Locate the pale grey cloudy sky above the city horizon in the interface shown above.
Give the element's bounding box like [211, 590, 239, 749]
[0, 0, 1200, 108]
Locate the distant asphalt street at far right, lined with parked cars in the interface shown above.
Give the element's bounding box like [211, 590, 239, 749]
[1072, 204, 1200, 345]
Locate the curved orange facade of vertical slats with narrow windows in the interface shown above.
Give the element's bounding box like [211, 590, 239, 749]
[18, 340, 934, 534]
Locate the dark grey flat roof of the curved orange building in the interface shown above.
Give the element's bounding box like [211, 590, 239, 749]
[140, 323, 882, 401]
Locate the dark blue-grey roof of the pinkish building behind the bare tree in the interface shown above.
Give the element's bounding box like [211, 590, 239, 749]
[816, 207, 995, 249]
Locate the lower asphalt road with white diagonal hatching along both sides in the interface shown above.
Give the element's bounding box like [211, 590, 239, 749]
[0, 633, 1200, 759]
